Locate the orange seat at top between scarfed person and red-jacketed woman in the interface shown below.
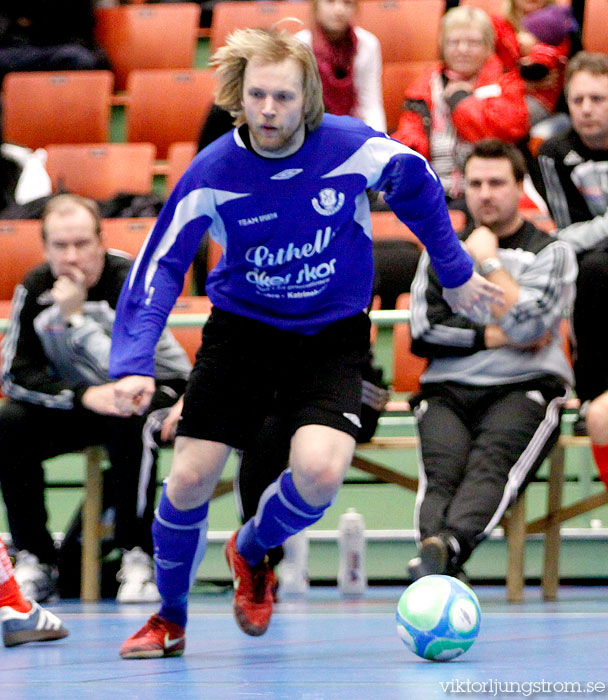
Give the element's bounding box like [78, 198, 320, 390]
[356, 0, 445, 63]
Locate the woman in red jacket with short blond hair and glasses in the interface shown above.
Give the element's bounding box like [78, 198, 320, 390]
[393, 6, 528, 199]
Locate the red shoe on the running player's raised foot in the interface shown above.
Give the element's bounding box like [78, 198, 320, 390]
[224, 532, 275, 637]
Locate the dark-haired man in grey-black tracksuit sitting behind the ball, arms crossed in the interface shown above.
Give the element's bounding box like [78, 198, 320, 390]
[408, 139, 576, 578]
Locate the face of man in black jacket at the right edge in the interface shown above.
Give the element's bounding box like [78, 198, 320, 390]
[568, 71, 608, 149]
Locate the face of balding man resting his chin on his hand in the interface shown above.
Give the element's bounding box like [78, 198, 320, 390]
[44, 207, 105, 288]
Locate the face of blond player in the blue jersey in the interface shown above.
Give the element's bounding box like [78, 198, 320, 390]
[243, 58, 304, 158]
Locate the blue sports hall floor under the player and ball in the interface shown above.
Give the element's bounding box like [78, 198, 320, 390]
[0, 586, 608, 700]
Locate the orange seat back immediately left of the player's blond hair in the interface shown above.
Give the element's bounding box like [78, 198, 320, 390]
[127, 69, 215, 159]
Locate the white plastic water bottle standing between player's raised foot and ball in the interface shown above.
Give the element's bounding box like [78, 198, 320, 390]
[338, 508, 367, 597]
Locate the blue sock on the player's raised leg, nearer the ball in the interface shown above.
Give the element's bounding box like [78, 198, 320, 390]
[236, 469, 331, 566]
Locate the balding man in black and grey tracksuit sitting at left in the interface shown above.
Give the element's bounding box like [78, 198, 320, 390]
[0, 195, 190, 602]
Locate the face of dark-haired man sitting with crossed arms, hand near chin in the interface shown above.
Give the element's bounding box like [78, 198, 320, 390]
[464, 156, 522, 235]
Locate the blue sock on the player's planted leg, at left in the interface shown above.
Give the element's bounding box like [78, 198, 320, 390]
[152, 484, 209, 627]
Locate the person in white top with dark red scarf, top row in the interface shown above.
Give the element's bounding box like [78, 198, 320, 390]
[296, 0, 386, 131]
